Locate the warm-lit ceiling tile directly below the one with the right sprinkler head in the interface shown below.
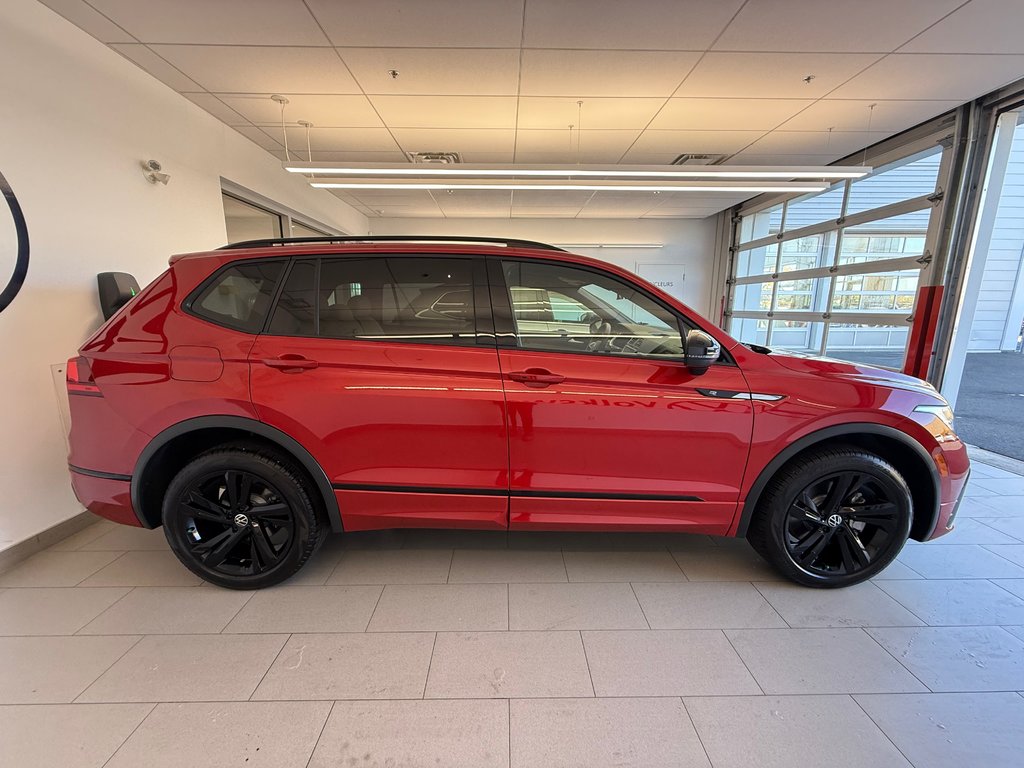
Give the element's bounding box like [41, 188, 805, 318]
[650, 98, 814, 131]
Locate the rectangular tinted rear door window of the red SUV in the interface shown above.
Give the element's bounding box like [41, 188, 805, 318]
[318, 257, 476, 345]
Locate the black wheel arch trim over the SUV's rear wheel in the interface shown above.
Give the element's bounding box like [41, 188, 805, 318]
[131, 416, 344, 532]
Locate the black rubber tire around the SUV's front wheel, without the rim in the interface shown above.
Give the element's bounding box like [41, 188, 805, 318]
[768, 454, 913, 588]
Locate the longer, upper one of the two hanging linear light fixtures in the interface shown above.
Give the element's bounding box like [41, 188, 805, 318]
[284, 162, 871, 179]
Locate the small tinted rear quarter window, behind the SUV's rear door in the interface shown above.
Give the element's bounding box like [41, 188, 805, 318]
[191, 261, 285, 333]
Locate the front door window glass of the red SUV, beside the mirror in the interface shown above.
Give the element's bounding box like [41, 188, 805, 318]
[502, 261, 683, 356]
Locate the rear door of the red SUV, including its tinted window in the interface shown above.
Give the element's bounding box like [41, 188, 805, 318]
[250, 254, 508, 530]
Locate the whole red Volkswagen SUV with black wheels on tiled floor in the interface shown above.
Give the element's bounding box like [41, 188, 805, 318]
[68, 238, 969, 589]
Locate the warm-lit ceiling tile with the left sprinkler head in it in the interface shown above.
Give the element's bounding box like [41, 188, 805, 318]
[338, 48, 519, 96]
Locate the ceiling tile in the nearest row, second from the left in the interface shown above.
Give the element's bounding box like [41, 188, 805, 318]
[89, 0, 329, 45]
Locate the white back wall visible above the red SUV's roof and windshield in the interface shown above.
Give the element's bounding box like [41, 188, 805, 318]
[370, 216, 721, 321]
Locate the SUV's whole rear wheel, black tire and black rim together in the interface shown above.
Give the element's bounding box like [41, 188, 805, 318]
[162, 445, 328, 590]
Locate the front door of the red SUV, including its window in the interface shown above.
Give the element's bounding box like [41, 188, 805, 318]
[488, 257, 753, 534]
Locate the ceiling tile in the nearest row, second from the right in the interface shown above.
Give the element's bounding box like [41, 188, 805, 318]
[714, 0, 964, 53]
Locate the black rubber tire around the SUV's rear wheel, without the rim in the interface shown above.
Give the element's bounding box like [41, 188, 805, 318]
[161, 451, 315, 590]
